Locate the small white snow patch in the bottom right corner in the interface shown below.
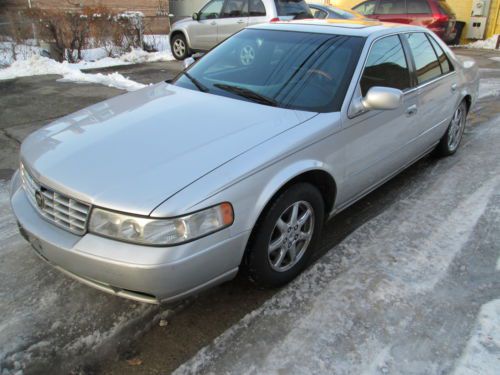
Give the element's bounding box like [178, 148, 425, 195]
[454, 299, 500, 375]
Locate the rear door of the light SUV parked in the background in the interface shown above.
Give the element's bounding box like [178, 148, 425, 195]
[217, 0, 248, 42]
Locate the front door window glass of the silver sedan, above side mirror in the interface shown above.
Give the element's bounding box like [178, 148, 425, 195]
[360, 35, 410, 96]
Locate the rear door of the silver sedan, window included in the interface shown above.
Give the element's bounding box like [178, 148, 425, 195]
[405, 32, 459, 150]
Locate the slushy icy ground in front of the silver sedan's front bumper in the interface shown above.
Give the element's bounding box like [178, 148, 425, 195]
[0, 180, 164, 375]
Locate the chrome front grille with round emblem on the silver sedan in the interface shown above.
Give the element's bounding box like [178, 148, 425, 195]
[20, 164, 90, 235]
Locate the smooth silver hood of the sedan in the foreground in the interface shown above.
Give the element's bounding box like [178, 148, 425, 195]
[21, 83, 315, 215]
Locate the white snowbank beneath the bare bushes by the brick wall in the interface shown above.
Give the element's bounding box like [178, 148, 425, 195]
[0, 35, 174, 91]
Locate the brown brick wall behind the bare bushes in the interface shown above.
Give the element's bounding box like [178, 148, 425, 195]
[0, 0, 170, 34]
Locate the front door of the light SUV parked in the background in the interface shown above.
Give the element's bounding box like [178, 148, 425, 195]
[189, 0, 224, 51]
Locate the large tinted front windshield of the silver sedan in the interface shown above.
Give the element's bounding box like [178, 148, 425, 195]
[174, 29, 364, 112]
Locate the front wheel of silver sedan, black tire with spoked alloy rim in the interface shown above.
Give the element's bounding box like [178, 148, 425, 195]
[244, 183, 324, 288]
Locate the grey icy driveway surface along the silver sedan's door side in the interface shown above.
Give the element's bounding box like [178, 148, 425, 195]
[176, 99, 500, 375]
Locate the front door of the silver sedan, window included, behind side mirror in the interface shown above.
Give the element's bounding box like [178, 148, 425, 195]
[339, 35, 418, 202]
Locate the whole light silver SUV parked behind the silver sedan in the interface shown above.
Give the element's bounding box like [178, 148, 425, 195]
[170, 0, 312, 60]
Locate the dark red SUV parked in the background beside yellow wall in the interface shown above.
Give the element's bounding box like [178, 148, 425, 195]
[352, 0, 456, 42]
